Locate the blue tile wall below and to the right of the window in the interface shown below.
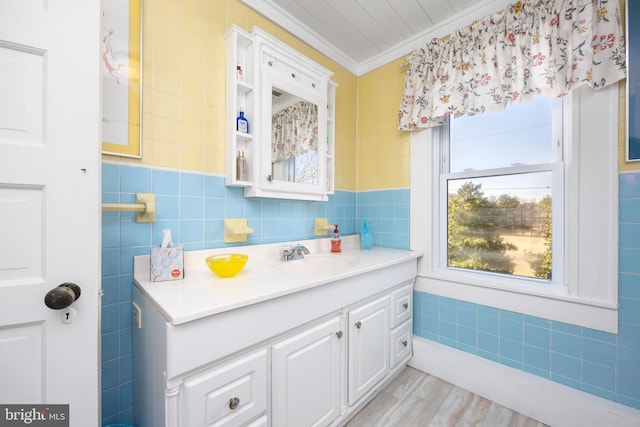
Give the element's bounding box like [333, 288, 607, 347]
[414, 173, 640, 409]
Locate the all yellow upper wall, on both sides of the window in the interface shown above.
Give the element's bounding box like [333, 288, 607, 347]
[104, 0, 640, 191]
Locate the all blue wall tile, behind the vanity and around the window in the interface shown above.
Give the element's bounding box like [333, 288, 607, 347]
[102, 164, 640, 424]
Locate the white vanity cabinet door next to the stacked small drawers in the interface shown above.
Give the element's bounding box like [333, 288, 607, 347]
[349, 295, 390, 405]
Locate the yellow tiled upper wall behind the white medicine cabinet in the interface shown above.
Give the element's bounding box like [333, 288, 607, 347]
[104, 0, 356, 190]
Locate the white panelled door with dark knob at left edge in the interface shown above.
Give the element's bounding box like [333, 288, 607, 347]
[0, 0, 101, 427]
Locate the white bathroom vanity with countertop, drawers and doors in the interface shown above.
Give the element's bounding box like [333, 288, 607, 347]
[133, 236, 421, 427]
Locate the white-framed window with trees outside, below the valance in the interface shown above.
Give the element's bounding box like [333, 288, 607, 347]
[411, 85, 619, 332]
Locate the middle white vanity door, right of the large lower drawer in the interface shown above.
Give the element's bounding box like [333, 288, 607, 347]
[271, 316, 346, 427]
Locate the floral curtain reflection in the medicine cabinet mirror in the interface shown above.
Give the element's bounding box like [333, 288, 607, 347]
[271, 101, 318, 162]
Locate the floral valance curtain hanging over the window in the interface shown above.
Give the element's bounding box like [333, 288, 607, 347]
[399, 0, 629, 130]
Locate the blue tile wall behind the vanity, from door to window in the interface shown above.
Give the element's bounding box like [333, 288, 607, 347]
[102, 163, 409, 424]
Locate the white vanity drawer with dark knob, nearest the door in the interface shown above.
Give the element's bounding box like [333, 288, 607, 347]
[182, 349, 267, 427]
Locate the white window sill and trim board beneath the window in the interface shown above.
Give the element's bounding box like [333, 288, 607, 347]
[414, 273, 618, 334]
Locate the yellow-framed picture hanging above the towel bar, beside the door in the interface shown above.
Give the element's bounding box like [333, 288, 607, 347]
[100, 0, 142, 158]
